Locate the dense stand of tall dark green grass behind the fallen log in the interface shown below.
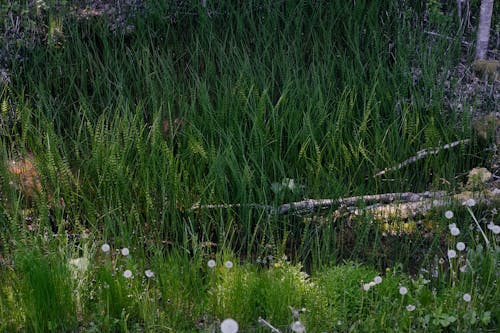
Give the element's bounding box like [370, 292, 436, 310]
[4, 2, 480, 259]
